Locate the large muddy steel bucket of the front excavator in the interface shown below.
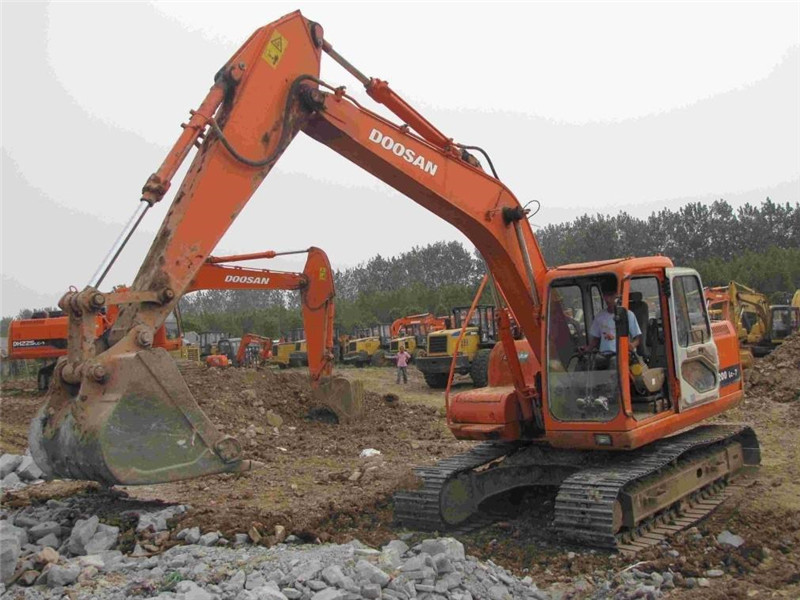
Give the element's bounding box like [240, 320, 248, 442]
[29, 348, 259, 485]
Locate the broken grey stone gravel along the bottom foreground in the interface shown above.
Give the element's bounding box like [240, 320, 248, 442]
[0, 455, 692, 600]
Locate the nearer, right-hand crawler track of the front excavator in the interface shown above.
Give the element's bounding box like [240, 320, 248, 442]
[553, 425, 760, 548]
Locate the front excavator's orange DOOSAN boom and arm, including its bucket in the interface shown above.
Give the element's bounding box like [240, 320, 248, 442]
[30, 12, 547, 483]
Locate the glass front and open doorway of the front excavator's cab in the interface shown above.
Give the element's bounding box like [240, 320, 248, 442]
[547, 275, 671, 422]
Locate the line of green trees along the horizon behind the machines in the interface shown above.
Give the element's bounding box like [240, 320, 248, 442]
[3, 198, 800, 337]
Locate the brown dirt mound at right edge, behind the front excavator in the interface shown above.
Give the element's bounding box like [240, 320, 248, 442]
[746, 333, 800, 402]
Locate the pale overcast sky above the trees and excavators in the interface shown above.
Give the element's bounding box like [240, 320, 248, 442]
[0, 2, 800, 315]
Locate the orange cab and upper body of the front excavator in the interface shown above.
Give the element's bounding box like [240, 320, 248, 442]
[448, 257, 742, 449]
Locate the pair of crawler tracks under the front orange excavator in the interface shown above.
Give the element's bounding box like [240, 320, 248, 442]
[394, 425, 760, 553]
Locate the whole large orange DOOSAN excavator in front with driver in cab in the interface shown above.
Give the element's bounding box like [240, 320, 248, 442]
[30, 12, 760, 548]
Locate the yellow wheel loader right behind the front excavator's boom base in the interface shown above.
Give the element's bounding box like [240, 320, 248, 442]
[415, 305, 497, 388]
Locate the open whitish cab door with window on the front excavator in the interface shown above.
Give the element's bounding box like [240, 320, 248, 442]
[666, 268, 719, 411]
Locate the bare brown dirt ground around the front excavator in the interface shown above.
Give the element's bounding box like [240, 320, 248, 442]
[0, 336, 800, 599]
